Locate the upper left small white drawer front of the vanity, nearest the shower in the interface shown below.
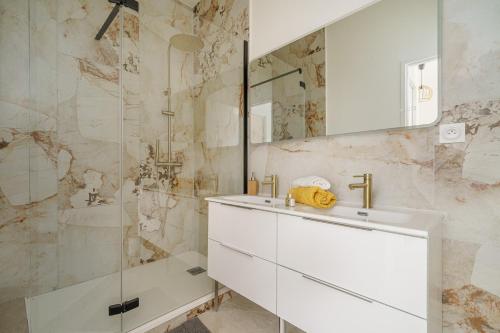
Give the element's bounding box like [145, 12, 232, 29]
[208, 202, 277, 262]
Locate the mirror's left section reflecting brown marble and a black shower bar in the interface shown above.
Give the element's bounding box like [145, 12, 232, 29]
[249, 30, 325, 143]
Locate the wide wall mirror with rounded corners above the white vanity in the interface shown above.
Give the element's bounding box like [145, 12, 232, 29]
[248, 0, 441, 143]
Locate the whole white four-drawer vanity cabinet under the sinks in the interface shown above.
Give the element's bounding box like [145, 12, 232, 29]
[208, 199, 441, 333]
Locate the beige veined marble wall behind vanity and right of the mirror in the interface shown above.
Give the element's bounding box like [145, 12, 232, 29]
[249, 0, 500, 333]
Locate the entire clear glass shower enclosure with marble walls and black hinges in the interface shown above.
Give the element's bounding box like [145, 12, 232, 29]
[0, 0, 246, 333]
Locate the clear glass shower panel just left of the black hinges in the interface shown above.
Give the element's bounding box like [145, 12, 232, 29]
[21, 0, 122, 333]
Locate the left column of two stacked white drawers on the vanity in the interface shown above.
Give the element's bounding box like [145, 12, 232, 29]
[208, 203, 277, 313]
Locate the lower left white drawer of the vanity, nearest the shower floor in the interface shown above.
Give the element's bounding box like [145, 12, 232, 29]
[208, 240, 276, 313]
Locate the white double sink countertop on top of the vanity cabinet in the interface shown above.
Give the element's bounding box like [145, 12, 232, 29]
[206, 195, 445, 238]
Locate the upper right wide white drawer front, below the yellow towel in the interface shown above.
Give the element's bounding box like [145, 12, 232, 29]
[277, 215, 427, 318]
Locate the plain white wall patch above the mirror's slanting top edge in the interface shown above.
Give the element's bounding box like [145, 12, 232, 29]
[250, 0, 377, 60]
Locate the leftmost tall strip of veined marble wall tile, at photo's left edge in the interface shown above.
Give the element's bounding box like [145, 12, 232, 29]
[0, 0, 57, 312]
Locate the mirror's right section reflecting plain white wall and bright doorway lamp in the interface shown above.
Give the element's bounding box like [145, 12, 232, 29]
[326, 0, 438, 134]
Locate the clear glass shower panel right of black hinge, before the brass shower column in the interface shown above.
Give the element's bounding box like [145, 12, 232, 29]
[122, 0, 243, 331]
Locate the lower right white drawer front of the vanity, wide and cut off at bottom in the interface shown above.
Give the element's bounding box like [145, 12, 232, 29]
[277, 266, 427, 333]
